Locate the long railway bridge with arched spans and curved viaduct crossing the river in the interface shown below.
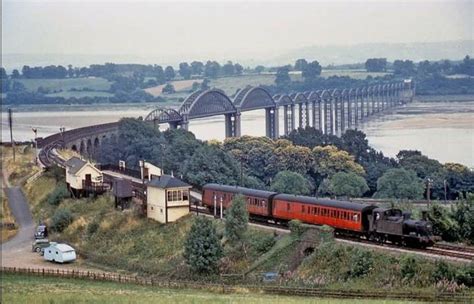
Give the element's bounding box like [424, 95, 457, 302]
[38, 80, 415, 164]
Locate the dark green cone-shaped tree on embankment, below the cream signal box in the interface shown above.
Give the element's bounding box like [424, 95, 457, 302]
[183, 216, 223, 273]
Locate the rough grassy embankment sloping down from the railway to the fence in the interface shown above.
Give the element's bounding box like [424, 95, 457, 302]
[25, 162, 474, 292]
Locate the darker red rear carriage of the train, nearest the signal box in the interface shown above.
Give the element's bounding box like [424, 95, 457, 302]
[202, 184, 277, 217]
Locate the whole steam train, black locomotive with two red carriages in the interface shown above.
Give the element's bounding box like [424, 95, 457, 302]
[202, 184, 437, 248]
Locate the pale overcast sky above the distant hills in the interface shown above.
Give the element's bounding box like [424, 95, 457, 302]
[2, 0, 474, 63]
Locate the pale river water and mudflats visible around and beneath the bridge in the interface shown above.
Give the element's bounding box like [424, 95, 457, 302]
[2, 100, 474, 167]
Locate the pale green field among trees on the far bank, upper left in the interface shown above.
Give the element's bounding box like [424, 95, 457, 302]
[17, 77, 112, 93]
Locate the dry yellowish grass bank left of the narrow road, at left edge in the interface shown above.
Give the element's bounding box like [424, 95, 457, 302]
[0, 146, 41, 242]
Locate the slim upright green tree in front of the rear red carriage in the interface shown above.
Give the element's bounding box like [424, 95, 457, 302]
[224, 195, 249, 245]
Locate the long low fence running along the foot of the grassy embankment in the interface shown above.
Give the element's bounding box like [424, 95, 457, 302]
[1, 267, 474, 303]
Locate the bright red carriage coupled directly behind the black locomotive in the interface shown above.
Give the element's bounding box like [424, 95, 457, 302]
[272, 194, 376, 232]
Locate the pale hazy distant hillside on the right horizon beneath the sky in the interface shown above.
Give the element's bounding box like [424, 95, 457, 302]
[268, 40, 474, 65]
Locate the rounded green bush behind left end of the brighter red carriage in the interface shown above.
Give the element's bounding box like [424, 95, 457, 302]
[271, 171, 311, 195]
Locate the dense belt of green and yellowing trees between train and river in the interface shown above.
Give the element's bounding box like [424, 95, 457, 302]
[100, 119, 474, 199]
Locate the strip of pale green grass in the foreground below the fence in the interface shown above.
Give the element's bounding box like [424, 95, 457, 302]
[2, 274, 422, 304]
